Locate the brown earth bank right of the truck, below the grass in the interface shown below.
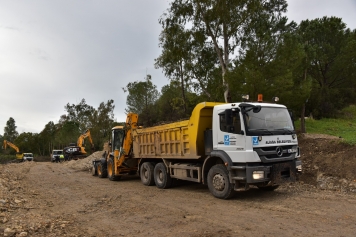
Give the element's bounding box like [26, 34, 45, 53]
[298, 134, 356, 191]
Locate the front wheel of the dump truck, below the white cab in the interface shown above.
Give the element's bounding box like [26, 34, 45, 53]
[208, 164, 235, 199]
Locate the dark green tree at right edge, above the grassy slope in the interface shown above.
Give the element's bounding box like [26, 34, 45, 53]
[299, 17, 356, 118]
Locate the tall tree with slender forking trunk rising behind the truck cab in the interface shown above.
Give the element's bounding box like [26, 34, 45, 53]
[160, 0, 287, 102]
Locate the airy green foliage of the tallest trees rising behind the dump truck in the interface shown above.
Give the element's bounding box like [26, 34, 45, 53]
[156, 0, 287, 102]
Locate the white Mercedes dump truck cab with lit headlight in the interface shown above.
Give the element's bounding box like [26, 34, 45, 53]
[206, 103, 301, 193]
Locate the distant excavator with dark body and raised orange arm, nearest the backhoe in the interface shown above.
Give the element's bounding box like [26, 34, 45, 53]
[63, 129, 94, 160]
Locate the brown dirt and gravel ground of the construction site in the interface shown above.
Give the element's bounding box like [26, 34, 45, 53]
[0, 135, 356, 237]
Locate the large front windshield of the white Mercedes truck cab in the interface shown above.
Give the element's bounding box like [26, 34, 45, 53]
[244, 107, 295, 135]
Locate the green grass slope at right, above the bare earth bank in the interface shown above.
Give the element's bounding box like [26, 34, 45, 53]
[295, 105, 356, 145]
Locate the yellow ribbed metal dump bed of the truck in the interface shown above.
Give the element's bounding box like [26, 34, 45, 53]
[133, 102, 221, 159]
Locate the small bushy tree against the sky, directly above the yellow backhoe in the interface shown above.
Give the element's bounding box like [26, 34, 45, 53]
[122, 75, 159, 126]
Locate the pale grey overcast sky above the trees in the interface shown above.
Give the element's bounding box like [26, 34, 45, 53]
[0, 0, 356, 135]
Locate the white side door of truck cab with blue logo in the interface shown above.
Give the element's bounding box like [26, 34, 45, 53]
[216, 109, 246, 162]
